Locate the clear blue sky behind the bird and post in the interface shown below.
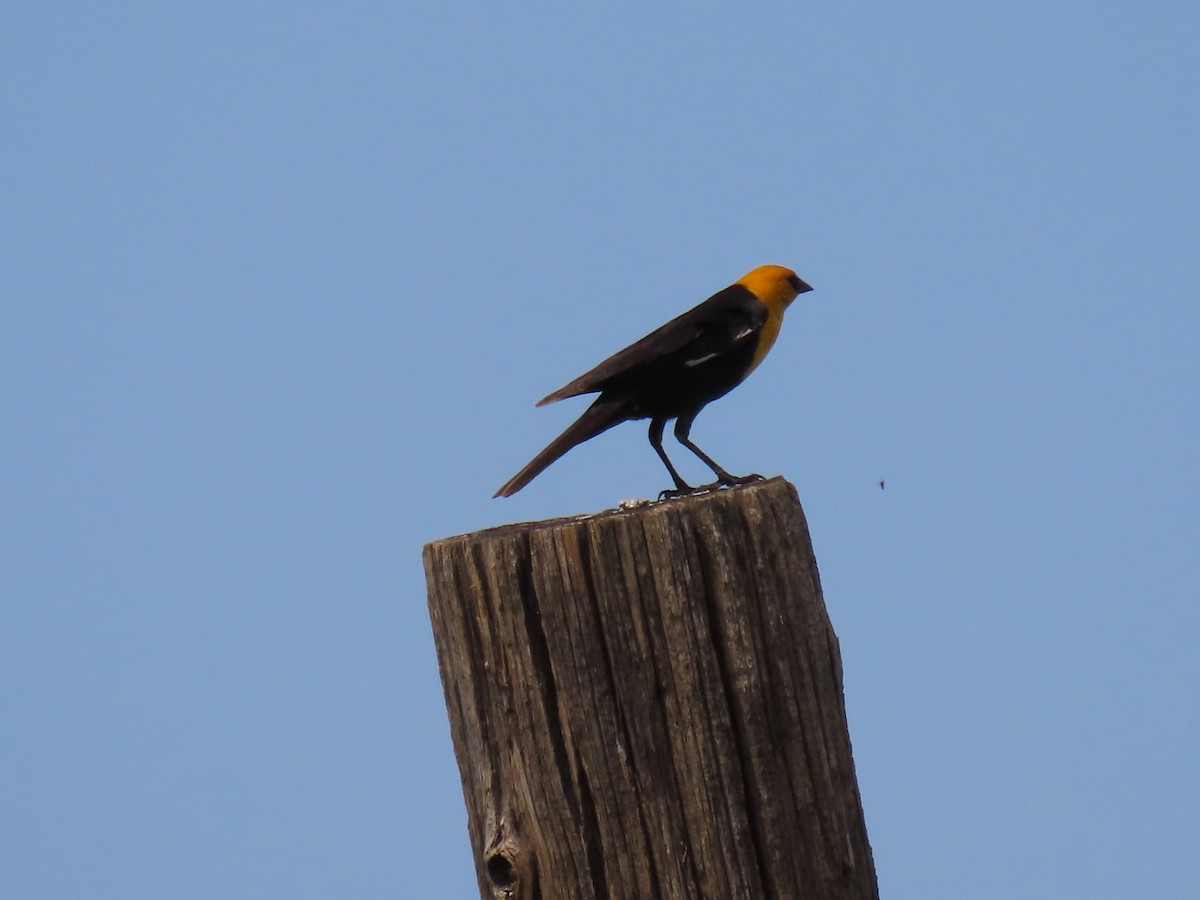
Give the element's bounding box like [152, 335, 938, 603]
[0, 2, 1200, 900]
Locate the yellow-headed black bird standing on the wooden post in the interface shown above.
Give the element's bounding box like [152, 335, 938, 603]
[492, 265, 812, 499]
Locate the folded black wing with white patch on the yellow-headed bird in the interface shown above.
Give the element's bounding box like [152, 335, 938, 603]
[538, 284, 767, 406]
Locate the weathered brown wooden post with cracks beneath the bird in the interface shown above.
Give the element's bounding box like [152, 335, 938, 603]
[425, 479, 878, 900]
